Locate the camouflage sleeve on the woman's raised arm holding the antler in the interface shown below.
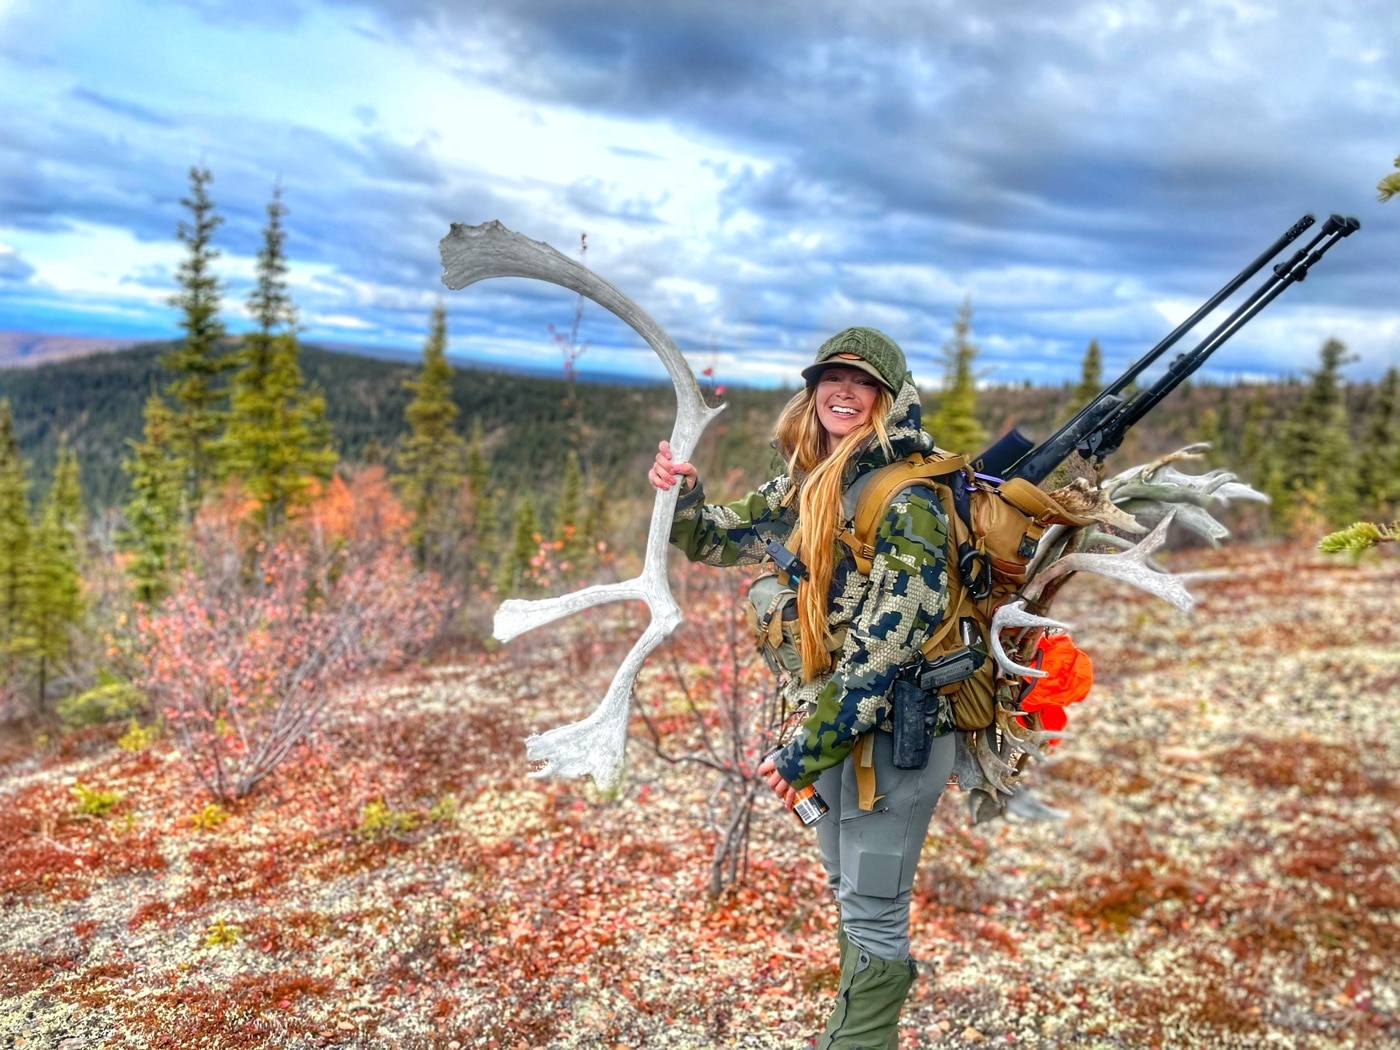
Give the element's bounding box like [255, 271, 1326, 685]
[671, 475, 797, 566]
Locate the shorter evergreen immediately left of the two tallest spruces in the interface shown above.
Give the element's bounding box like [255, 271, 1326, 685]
[119, 393, 186, 603]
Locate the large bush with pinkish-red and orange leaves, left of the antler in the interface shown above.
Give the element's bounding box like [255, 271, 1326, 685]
[137, 469, 449, 799]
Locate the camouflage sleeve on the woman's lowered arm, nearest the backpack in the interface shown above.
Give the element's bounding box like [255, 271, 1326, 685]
[774, 487, 951, 788]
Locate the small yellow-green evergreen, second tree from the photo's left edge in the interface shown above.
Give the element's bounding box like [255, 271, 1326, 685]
[29, 447, 84, 707]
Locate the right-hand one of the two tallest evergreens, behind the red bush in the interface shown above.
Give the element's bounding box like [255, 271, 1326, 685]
[218, 188, 336, 529]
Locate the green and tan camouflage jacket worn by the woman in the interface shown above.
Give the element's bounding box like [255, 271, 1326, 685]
[671, 382, 953, 787]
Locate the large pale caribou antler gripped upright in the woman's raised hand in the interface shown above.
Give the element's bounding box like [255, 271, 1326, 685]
[438, 221, 724, 790]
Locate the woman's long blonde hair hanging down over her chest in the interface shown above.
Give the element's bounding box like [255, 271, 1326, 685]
[773, 386, 895, 682]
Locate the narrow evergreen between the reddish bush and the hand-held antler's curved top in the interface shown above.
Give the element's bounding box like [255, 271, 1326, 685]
[399, 300, 466, 573]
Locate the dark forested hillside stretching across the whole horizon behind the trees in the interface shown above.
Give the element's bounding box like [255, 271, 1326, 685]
[0, 343, 1400, 534]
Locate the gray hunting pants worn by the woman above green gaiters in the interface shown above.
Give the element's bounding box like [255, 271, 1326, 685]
[816, 731, 955, 960]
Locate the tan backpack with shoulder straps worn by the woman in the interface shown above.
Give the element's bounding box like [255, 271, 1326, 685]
[749, 449, 1091, 731]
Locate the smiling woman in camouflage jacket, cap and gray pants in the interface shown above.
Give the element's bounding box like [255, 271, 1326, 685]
[648, 328, 953, 1049]
